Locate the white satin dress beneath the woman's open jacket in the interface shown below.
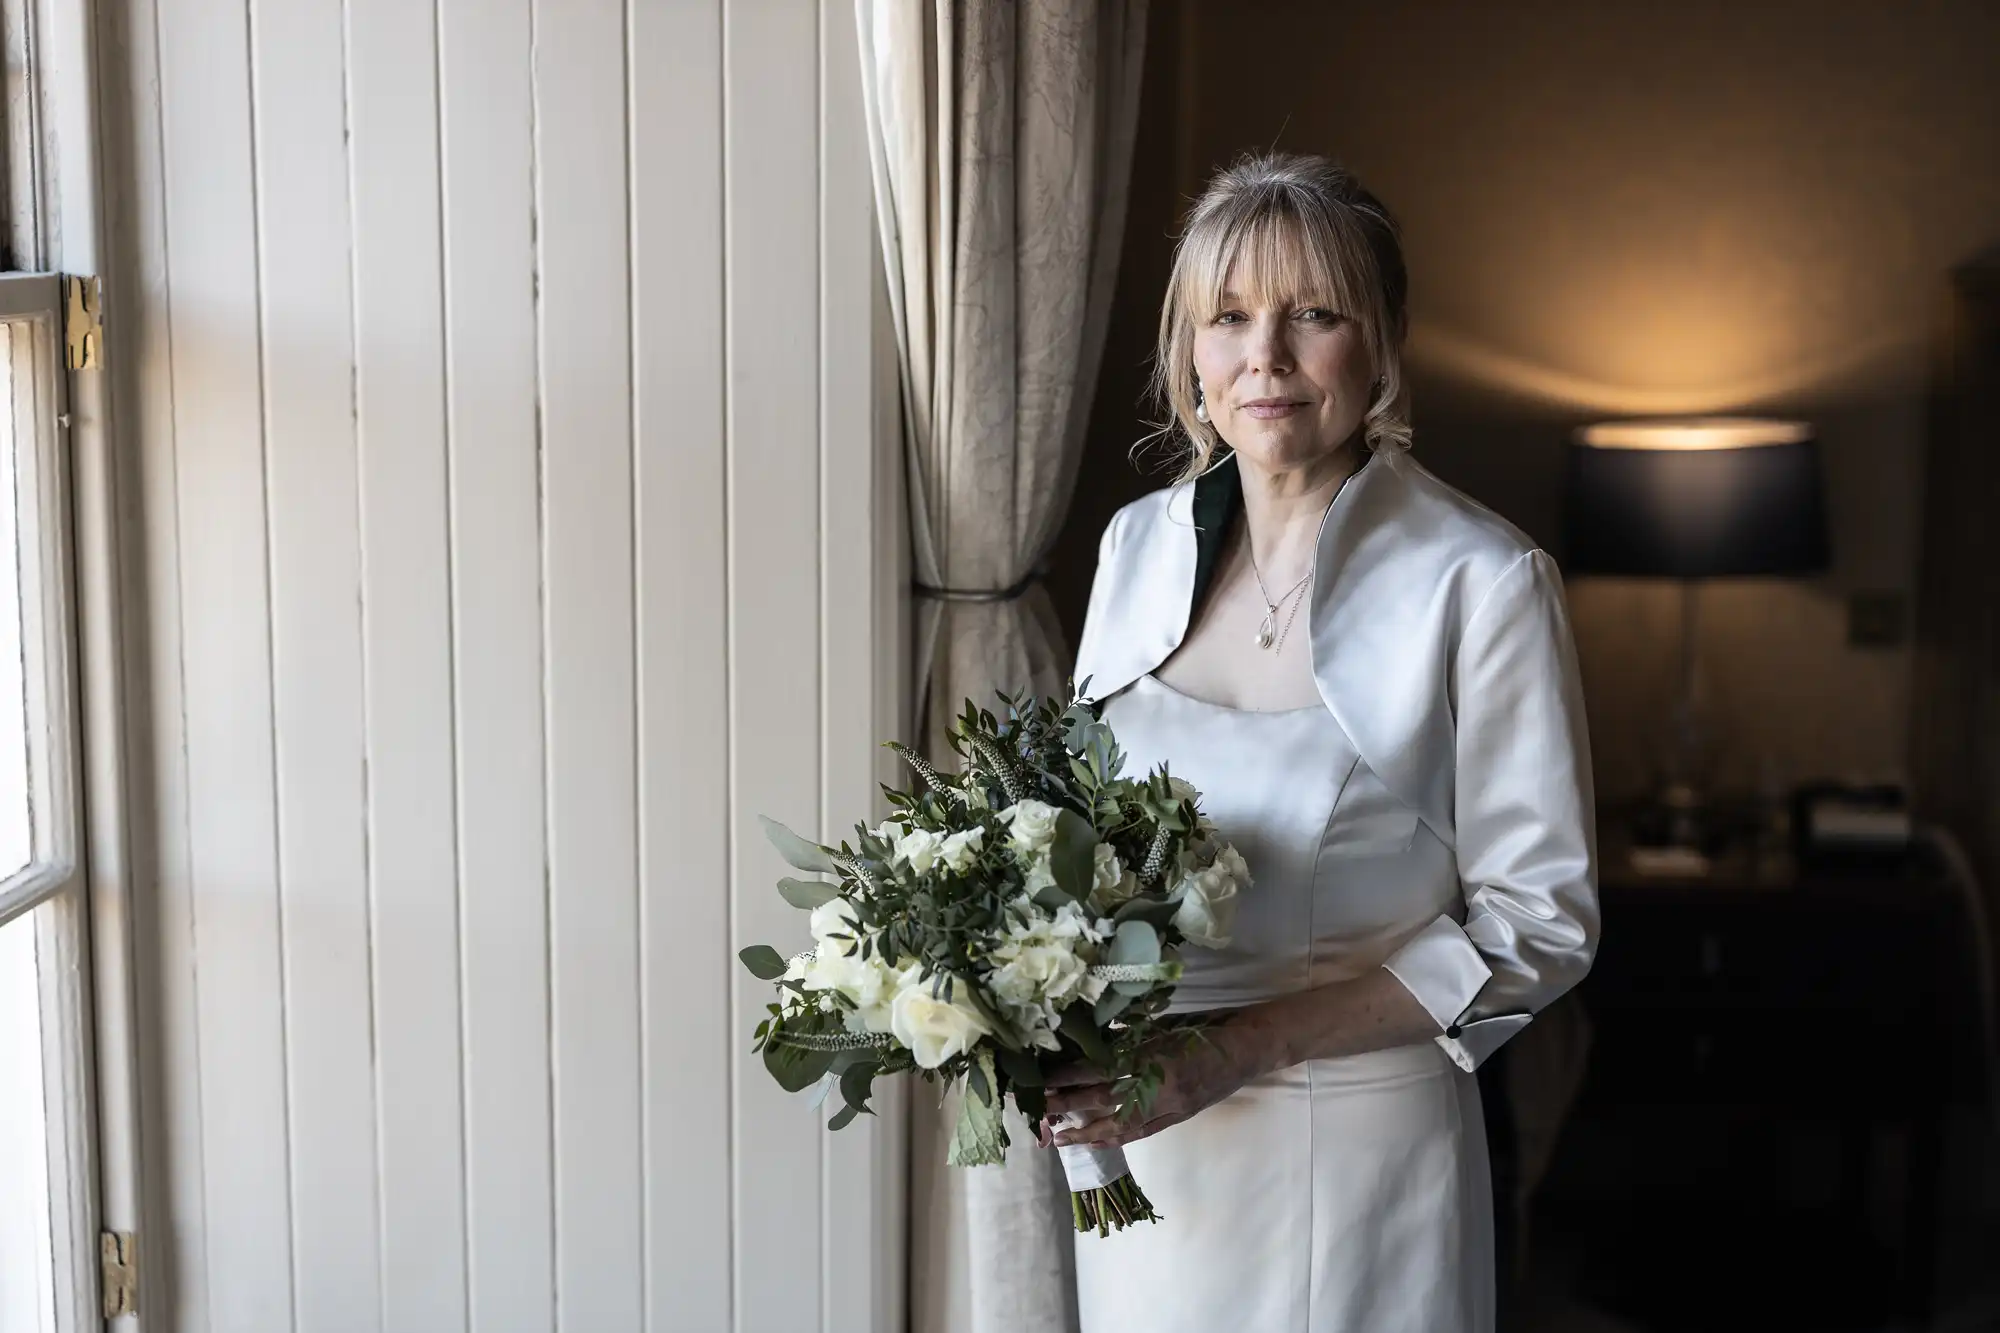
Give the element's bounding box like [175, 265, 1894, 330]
[1076, 673, 1494, 1333]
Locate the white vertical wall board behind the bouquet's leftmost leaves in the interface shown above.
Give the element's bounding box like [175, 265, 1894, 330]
[722, 0, 826, 1333]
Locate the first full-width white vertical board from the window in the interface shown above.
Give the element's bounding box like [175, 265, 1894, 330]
[158, 0, 292, 1333]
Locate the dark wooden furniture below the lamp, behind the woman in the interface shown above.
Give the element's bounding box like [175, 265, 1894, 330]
[1536, 844, 1978, 1333]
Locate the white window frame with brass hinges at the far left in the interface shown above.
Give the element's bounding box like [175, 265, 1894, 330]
[0, 0, 143, 1333]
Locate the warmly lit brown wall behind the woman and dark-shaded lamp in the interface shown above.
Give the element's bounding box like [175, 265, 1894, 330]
[1058, 0, 2000, 797]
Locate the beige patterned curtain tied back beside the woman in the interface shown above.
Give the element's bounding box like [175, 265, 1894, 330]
[856, 0, 1146, 1333]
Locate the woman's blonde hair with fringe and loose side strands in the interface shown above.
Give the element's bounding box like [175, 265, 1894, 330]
[1152, 152, 1410, 482]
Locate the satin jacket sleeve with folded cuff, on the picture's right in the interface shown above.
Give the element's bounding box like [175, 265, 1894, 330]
[1386, 550, 1598, 1071]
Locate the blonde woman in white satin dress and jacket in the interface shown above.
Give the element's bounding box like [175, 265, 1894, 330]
[1044, 154, 1598, 1333]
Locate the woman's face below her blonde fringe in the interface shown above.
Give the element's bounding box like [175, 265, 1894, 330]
[1194, 264, 1374, 472]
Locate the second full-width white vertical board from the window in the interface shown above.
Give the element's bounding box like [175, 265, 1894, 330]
[248, 0, 380, 1333]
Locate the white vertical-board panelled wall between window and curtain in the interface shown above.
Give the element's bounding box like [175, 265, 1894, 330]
[100, 0, 904, 1333]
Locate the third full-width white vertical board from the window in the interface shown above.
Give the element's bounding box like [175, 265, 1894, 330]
[348, 0, 468, 1333]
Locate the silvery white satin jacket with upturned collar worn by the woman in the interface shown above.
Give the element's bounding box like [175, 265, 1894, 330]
[1076, 452, 1598, 1069]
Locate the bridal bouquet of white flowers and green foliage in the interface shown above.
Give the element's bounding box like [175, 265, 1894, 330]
[738, 695, 1250, 1235]
